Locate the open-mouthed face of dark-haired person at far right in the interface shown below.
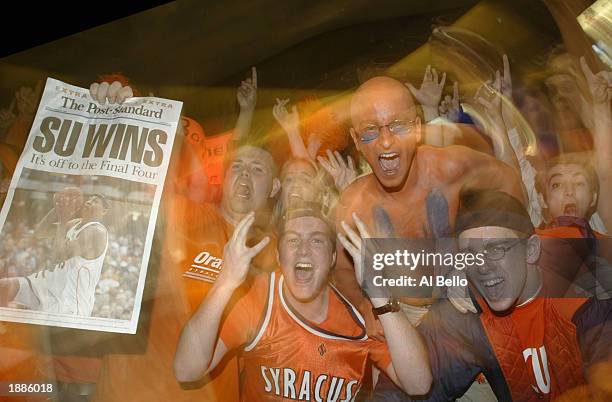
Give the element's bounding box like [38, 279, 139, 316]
[544, 164, 597, 220]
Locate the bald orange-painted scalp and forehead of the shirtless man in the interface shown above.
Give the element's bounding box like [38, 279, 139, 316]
[351, 77, 416, 129]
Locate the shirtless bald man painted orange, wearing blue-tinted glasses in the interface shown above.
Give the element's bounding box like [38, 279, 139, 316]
[334, 77, 523, 338]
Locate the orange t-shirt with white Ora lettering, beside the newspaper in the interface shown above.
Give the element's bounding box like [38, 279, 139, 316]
[93, 197, 275, 402]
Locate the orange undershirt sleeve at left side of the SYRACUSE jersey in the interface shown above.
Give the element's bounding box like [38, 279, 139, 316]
[219, 275, 269, 350]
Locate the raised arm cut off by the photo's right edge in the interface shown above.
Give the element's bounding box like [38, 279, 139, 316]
[580, 57, 612, 232]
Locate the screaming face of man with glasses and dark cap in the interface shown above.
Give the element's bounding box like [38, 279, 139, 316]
[459, 226, 527, 312]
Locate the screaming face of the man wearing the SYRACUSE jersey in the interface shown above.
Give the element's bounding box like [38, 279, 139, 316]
[278, 216, 336, 302]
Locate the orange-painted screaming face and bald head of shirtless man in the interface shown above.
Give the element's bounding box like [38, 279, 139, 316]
[351, 77, 420, 189]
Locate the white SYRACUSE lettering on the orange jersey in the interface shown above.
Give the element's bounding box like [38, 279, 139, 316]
[259, 366, 361, 402]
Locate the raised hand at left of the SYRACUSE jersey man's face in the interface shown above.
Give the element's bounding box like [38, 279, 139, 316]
[217, 212, 270, 288]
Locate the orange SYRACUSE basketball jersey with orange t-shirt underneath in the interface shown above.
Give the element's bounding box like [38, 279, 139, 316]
[220, 271, 391, 402]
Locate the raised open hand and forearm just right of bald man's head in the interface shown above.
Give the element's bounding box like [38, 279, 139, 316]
[406, 66, 446, 147]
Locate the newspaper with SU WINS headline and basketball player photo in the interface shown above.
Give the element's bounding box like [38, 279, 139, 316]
[0, 78, 182, 334]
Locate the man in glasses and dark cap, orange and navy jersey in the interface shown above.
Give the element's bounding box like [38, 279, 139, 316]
[376, 190, 612, 402]
